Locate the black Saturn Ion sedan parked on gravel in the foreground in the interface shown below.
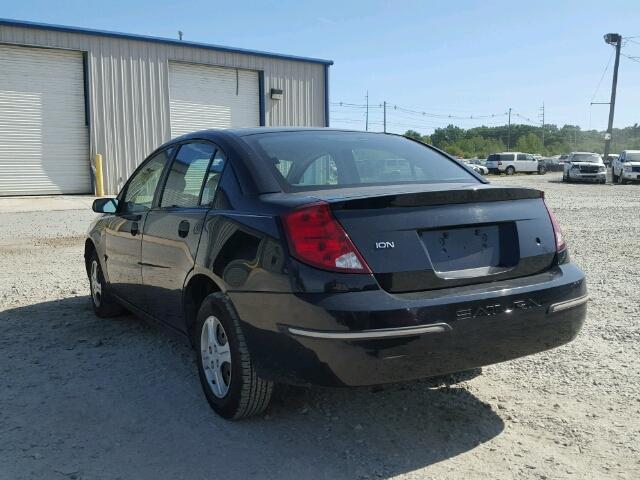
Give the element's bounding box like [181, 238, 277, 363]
[85, 128, 587, 418]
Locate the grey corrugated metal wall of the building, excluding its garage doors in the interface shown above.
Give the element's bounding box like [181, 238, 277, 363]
[0, 25, 325, 194]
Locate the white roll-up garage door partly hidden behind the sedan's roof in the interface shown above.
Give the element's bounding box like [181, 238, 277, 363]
[169, 62, 260, 137]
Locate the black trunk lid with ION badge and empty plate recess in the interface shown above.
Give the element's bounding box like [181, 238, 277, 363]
[318, 184, 556, 293]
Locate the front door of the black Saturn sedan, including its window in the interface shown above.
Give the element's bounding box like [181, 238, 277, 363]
[105, 149, 173, 311]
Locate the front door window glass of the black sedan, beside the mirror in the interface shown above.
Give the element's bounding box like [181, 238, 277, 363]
[123, 148, 173, 212]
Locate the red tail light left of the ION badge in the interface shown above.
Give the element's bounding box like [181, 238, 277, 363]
[282, 203, 371, 273]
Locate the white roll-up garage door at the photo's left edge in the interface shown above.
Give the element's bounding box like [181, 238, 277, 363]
[0, 45, 91, 195]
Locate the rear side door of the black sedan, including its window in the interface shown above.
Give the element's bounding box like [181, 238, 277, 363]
[142, 141, 224, 330]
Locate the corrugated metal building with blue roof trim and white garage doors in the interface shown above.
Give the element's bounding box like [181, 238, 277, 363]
[0, 19, 332, 195]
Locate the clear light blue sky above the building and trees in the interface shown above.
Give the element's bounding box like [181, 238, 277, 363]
[0, 0, 640, 133]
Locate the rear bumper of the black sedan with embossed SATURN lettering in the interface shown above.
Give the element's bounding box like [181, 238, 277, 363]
[229, 263, 587, 386]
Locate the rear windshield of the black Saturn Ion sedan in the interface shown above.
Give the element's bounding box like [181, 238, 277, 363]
[244, 131, 479, 191]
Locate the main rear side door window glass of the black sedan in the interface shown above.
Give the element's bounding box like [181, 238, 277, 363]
[160, 142, 215, 208]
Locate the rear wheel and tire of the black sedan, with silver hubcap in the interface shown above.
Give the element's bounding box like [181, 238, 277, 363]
[193, 293, 273, 420]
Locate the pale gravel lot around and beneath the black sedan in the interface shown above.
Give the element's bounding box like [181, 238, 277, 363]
[0, 174, 640, 479]
